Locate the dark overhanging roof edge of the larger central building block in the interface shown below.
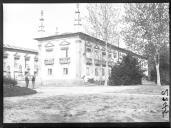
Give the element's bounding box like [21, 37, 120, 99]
[35, 32, 147, 59]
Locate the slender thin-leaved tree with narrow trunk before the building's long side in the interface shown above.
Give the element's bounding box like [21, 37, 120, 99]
[87, 4, 118, 85]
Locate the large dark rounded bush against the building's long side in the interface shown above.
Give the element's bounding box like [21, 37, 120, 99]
[109, 54, 144, 86]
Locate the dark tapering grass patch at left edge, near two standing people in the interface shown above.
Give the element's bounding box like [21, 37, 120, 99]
[3, 85, 37, 97]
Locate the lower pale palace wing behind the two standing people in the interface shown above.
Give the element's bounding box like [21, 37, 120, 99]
[3, 44, 38, 80]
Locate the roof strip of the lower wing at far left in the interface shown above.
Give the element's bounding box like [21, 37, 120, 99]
[3, 44, 38, 54]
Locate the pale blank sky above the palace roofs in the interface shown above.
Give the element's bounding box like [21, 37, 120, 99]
[3, 3, 125, 49]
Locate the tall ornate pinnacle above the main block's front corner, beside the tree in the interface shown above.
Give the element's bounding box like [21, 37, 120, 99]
[74, 3, 82, 32]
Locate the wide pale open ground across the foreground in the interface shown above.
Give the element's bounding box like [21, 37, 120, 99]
[4, 86, 169, 123]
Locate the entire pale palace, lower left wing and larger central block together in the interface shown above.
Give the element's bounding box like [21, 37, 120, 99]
[3, 32, 148, 84]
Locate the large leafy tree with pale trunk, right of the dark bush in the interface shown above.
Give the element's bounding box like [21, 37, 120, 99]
[124, 3, 169, 85]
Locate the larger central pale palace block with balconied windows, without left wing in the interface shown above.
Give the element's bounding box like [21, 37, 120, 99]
[35, 32, 148, 81]
